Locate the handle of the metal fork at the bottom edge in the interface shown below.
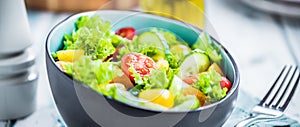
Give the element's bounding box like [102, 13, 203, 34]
[235, 114, 277, 127]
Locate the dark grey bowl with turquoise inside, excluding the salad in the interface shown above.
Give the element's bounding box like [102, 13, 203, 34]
[46, 10, 239, 127]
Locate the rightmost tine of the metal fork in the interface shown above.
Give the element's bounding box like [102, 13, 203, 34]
[272, 66, 300, 111]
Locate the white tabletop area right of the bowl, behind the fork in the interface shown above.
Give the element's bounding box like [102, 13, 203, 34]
[206, 0, 300, 121]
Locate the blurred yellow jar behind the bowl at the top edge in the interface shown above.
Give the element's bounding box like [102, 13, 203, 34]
[139, 0, 205, 29]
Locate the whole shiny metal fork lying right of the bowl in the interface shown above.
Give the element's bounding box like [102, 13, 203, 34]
[235, 65, 300, 127]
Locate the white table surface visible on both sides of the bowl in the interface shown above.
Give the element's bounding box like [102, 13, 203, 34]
[0, 0, 300, 127]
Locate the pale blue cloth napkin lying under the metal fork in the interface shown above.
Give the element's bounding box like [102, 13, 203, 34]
[223, 90, 300, 127]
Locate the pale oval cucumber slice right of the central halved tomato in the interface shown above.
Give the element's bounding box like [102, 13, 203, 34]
[177, 50, 210, 79]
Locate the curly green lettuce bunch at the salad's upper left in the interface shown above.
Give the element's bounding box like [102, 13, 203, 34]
[63, 15, 127, 60]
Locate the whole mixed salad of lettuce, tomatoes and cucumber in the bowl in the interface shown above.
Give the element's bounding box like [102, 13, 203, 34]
[52, 15, 231, 111]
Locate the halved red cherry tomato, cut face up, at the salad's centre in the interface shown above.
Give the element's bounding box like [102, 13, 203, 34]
[121, 52, 156, 82]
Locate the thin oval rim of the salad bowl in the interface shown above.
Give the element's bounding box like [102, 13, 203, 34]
[45, 10, 240, 113]
